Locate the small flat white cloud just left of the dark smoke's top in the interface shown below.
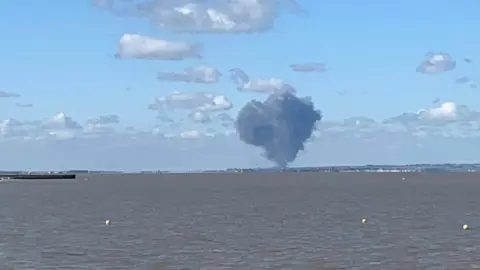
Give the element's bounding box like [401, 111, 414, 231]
[148, 91, 233, 112]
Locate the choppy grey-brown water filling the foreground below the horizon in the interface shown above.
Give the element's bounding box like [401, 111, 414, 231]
[0, 173, 480, 270]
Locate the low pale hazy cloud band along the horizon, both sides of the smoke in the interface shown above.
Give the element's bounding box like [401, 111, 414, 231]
[4, 101, 480, 170]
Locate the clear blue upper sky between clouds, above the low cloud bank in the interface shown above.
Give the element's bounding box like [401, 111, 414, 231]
[0, 0, 480, 125]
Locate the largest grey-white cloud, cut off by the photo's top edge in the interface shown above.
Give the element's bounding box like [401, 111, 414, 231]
[94, 0, 301, 33]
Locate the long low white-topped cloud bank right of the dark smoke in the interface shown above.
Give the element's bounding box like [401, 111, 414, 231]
[306, 102, 480, 144]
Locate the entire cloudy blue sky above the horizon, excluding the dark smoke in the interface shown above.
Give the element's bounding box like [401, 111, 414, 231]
[0, 0, 480, 170]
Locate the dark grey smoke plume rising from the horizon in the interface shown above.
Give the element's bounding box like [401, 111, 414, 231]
[235, 92, 322, 168]
